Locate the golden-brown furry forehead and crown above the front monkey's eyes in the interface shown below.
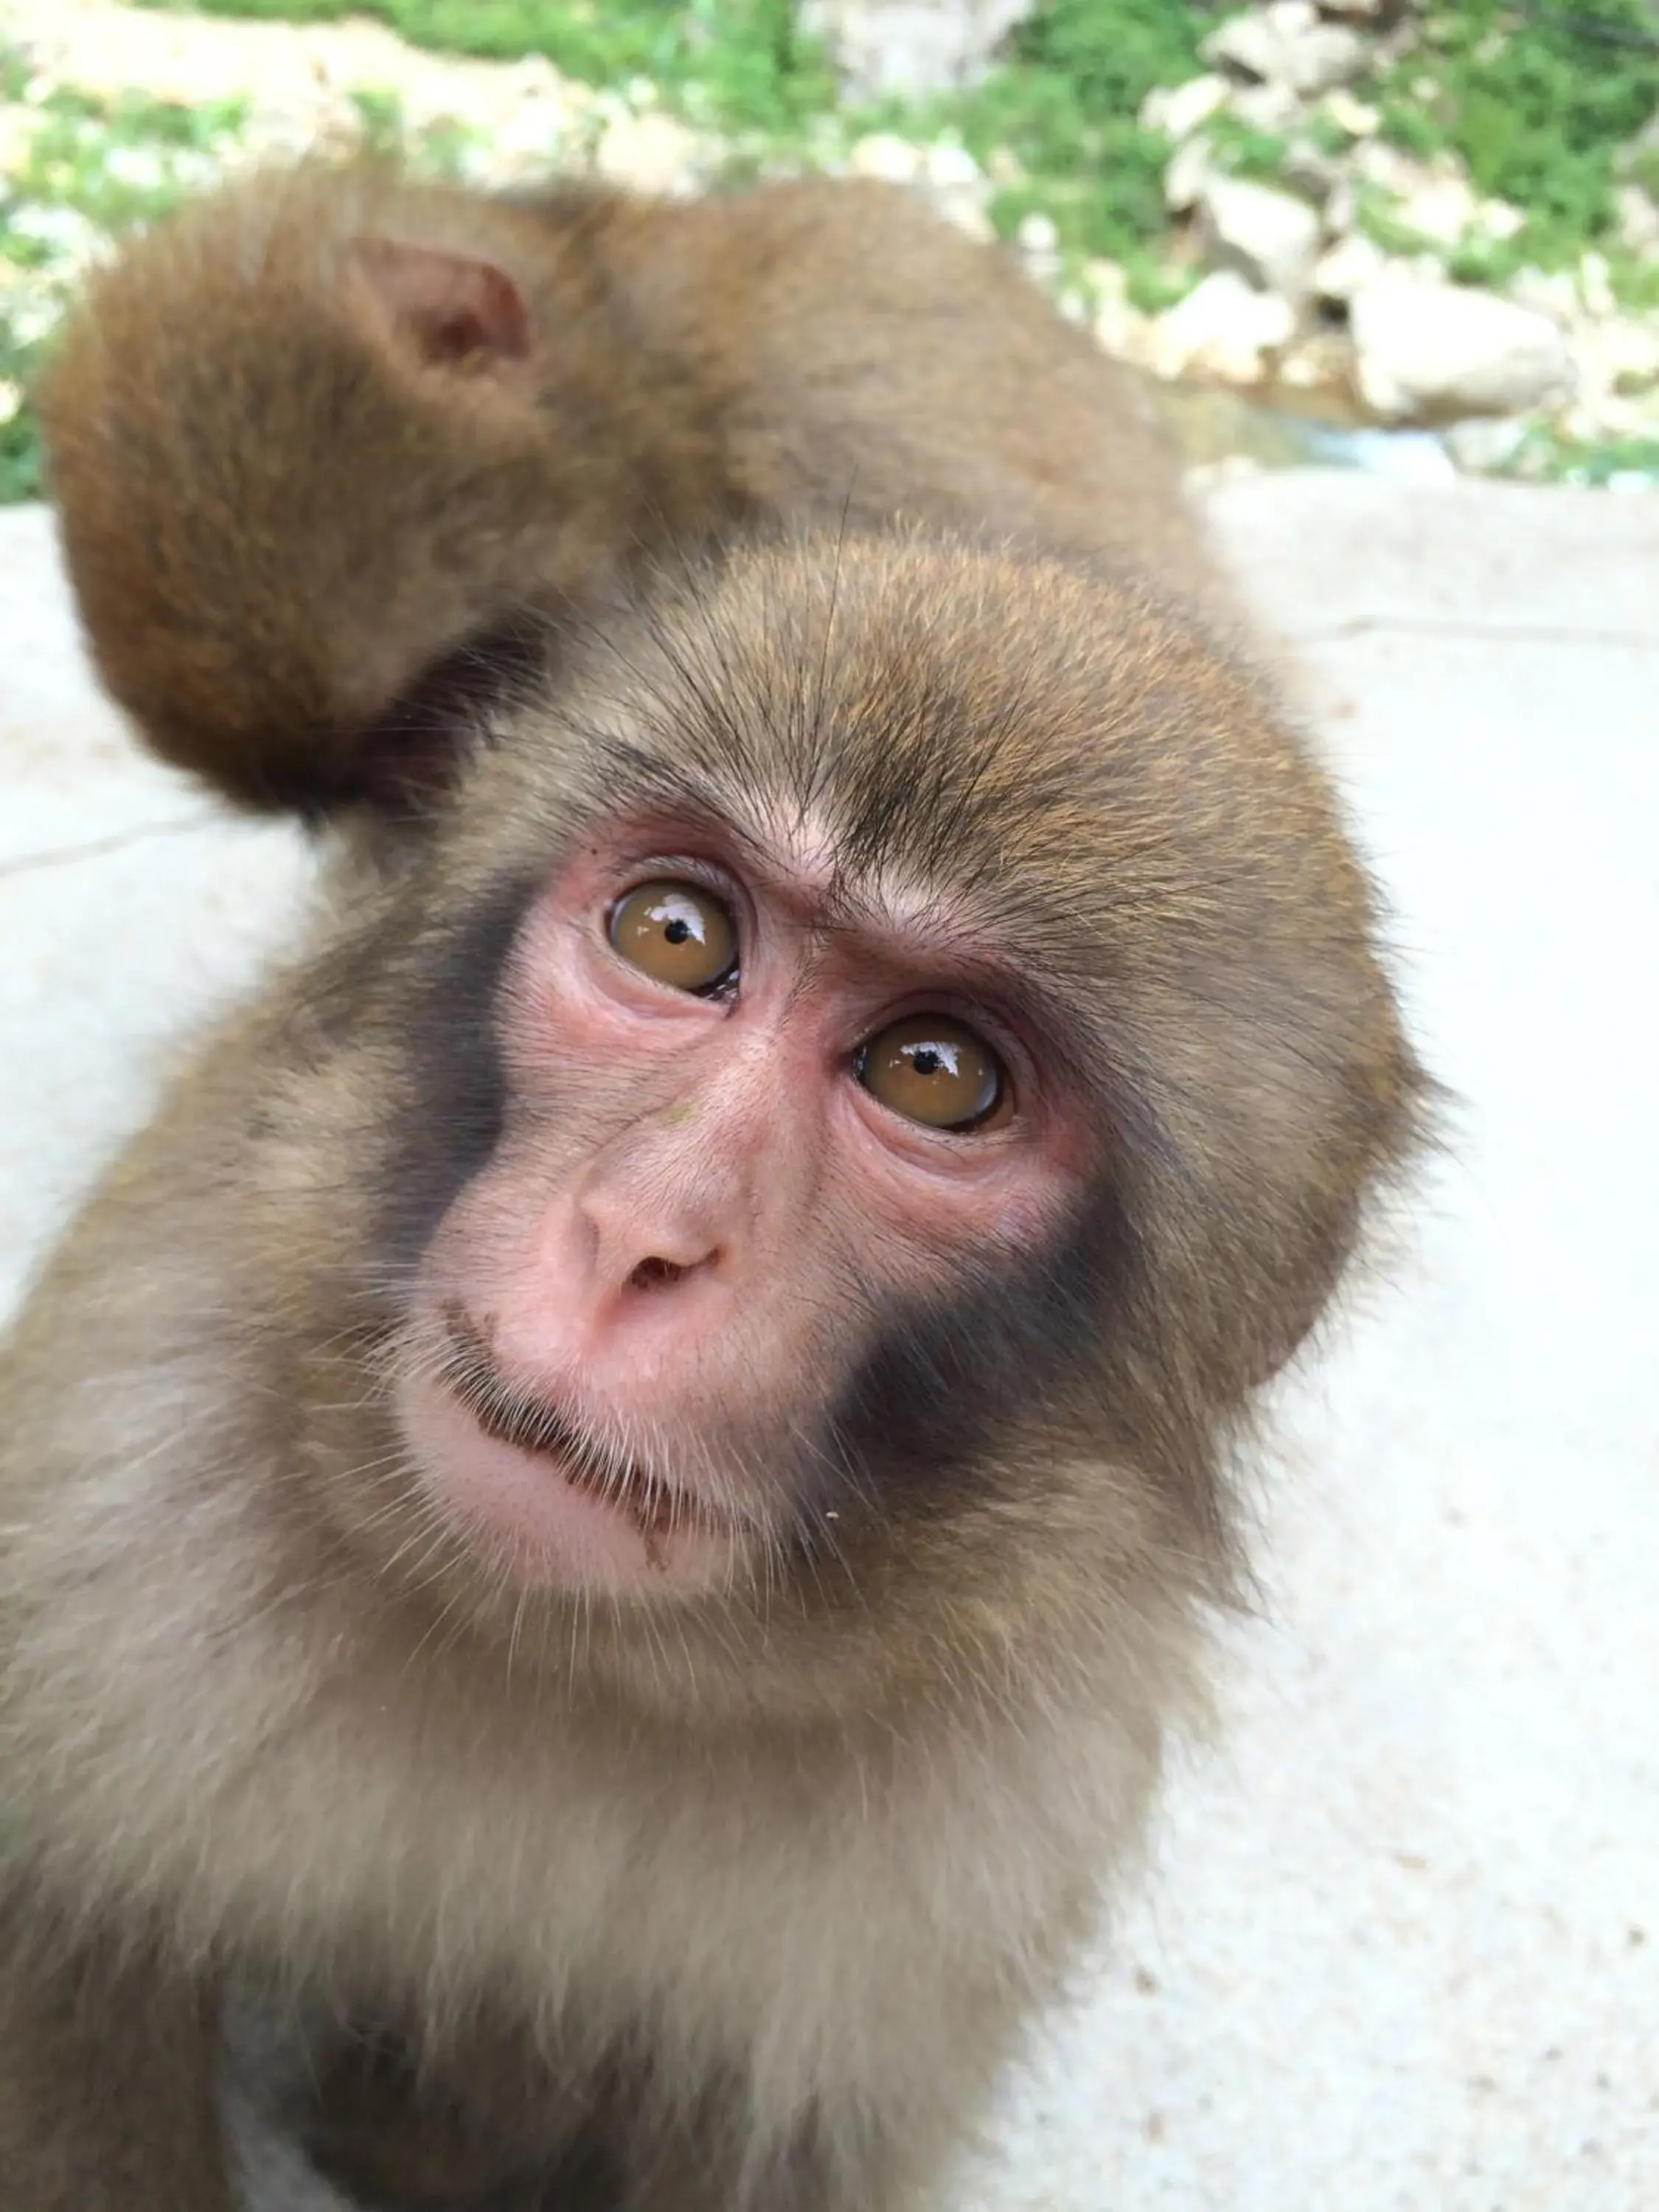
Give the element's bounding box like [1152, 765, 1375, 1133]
[456, 538, 1352, 969]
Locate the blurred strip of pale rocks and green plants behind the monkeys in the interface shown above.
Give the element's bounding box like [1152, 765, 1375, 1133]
[0, 0, 1659, 500]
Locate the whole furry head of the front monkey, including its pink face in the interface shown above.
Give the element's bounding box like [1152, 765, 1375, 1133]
[240, 542, 1418, 1701]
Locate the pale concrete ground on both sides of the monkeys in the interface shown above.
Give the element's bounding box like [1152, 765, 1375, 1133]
[0, 473, 1659, 2212]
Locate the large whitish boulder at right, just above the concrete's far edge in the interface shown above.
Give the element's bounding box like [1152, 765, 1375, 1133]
[1349, 270, 1573, 420]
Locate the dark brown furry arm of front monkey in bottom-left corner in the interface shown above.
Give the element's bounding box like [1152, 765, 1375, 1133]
[0, 1913, 230, 2212]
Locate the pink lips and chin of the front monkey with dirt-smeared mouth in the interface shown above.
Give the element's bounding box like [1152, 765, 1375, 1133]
[396, 1338, 737, 1595]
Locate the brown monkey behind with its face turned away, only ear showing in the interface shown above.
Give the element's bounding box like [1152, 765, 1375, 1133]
[38, 159, 1212, 810]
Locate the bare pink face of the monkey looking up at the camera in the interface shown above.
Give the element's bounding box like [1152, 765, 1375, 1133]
[387, 792, 1099, 1593]
